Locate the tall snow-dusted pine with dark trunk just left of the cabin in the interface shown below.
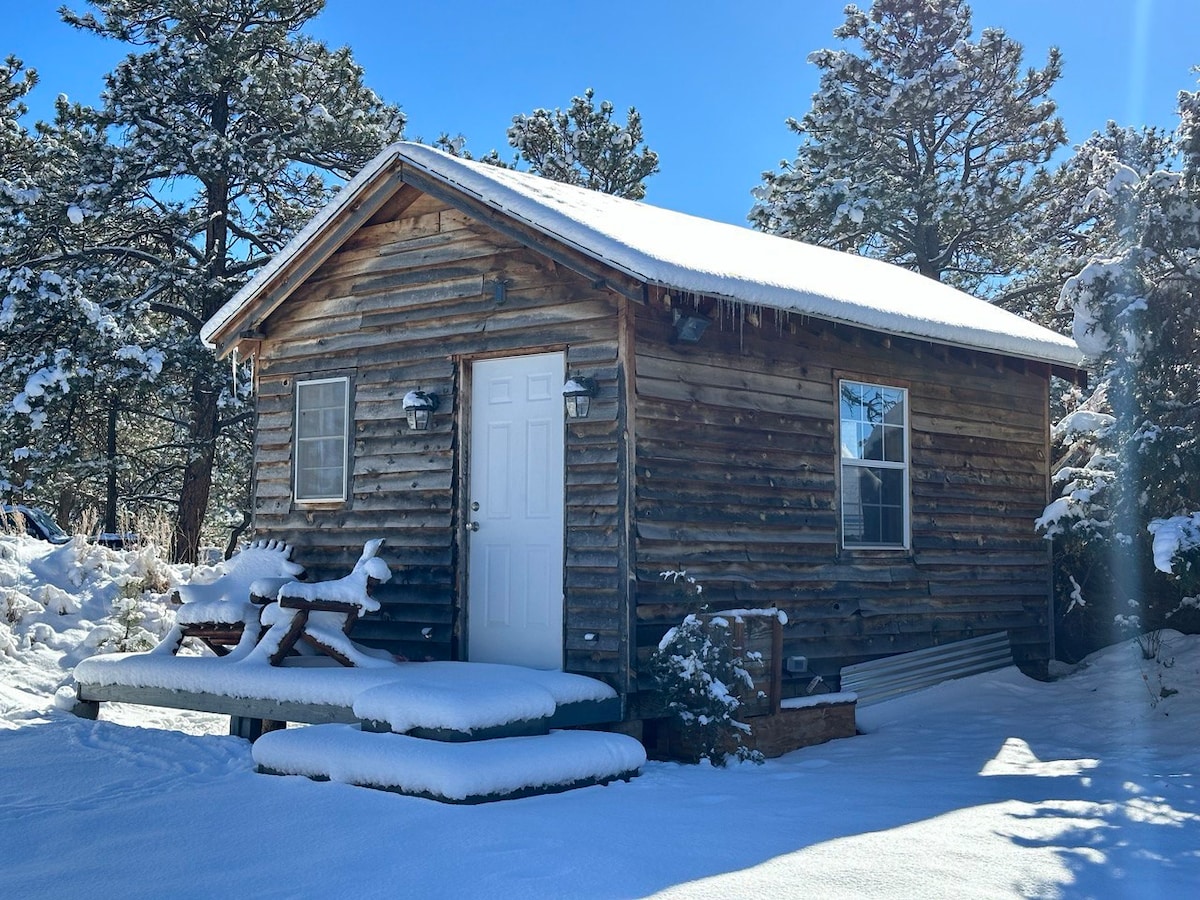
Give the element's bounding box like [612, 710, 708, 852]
[11, 0, 403, 560]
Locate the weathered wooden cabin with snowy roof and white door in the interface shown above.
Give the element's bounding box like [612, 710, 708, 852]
[202, 143, 1084, 719]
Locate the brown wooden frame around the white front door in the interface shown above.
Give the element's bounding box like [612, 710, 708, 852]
[451, 343, 570, 672]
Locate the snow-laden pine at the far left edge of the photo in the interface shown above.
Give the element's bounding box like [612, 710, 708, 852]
[0, 60, 158, 521]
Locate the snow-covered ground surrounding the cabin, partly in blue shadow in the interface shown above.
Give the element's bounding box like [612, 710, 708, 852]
[0, 536, 1200, 898]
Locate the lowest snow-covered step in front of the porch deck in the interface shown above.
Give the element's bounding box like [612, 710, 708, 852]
[253, 725, 646, 803]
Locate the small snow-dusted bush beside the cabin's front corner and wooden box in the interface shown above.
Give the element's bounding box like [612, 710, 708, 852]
[650, 571, 762, 766]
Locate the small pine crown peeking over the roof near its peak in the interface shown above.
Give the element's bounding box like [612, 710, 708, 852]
[509, 88, 659, 200]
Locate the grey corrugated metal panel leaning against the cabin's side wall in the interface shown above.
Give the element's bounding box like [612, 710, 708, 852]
[841, 631, 1013, 707]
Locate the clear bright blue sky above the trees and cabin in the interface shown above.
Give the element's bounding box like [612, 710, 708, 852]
[7, 0, 1200, 224]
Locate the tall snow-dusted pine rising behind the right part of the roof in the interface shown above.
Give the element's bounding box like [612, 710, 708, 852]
[750, 0, 1066, 303]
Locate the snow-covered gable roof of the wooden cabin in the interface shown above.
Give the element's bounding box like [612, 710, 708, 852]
[200, 143, 1084, 368]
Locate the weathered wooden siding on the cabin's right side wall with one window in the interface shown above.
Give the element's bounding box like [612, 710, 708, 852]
[635, 305, 1050, 688]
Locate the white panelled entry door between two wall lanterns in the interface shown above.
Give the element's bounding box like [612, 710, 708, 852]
[467, 353, 566, 668]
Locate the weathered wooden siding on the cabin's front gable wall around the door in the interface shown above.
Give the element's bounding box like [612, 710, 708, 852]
[254, 188, 628, 684]
